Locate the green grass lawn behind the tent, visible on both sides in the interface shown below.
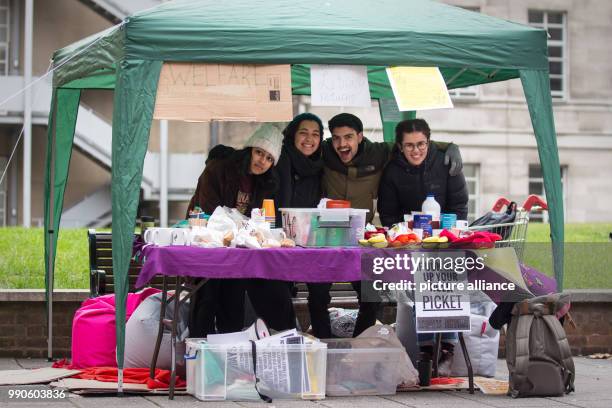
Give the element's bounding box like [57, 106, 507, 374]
[0, 223, 612, 289]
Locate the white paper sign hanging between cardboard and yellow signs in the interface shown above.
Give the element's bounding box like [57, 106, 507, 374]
[310, 65, 372, 107]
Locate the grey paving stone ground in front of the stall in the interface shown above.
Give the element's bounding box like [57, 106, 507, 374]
[0, 357, 612, 408]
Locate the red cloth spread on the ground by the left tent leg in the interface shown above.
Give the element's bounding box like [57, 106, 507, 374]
[72, 367, 187, 389]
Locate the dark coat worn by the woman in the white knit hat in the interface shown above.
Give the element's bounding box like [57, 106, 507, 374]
[187, 146, 278, 217]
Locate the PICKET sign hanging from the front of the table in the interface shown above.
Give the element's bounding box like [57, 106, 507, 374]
[414, 251, 471, 333]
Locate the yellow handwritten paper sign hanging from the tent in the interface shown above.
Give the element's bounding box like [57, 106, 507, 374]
[387, 67, 453, 111]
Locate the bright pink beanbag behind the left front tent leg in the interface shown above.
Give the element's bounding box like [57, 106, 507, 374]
[71, 288, 159, 368]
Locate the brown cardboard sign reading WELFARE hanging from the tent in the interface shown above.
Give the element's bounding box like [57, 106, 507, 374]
[153, 62, 293, 122]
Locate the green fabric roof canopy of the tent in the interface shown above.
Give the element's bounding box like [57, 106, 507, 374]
[54, 0, 548, 87]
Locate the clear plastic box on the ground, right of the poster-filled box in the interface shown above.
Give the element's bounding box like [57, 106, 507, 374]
[322, 338, 403, 396]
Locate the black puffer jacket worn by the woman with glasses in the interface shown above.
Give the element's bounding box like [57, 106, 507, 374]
[378, 143, 468, 226]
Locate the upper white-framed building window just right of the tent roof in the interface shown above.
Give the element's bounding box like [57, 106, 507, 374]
[528, 10, 568, 98]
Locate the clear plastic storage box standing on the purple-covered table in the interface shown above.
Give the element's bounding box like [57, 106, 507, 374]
[280, 208, 368, 247]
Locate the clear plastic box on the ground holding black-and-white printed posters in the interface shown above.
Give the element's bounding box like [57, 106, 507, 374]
[185, 339, 327, 401]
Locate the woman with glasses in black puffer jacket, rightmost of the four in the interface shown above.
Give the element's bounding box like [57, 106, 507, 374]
[378, 119, 468, 376]
